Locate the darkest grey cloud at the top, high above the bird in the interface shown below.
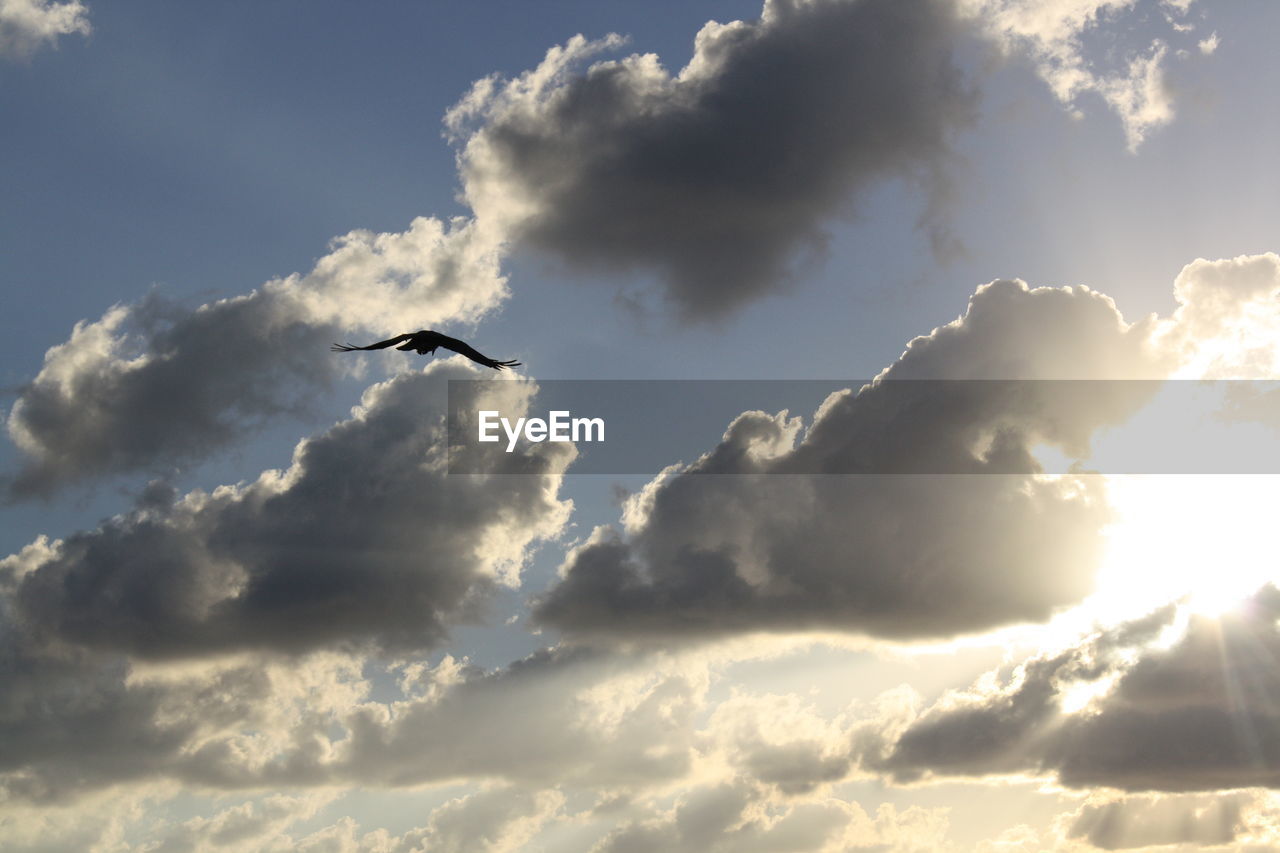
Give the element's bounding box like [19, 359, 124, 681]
[448, 0, 974, 318]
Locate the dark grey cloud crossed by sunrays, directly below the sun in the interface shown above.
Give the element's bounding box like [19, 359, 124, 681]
[880, 587, 1280, 788]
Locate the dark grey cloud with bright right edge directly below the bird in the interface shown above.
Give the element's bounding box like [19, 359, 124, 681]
[13, 364, 572, 658]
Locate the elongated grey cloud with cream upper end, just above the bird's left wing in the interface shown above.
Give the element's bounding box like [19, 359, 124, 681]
[8, 218, 506, 497]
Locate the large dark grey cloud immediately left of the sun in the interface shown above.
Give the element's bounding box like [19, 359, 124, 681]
[536, 280, 1155, 639]
